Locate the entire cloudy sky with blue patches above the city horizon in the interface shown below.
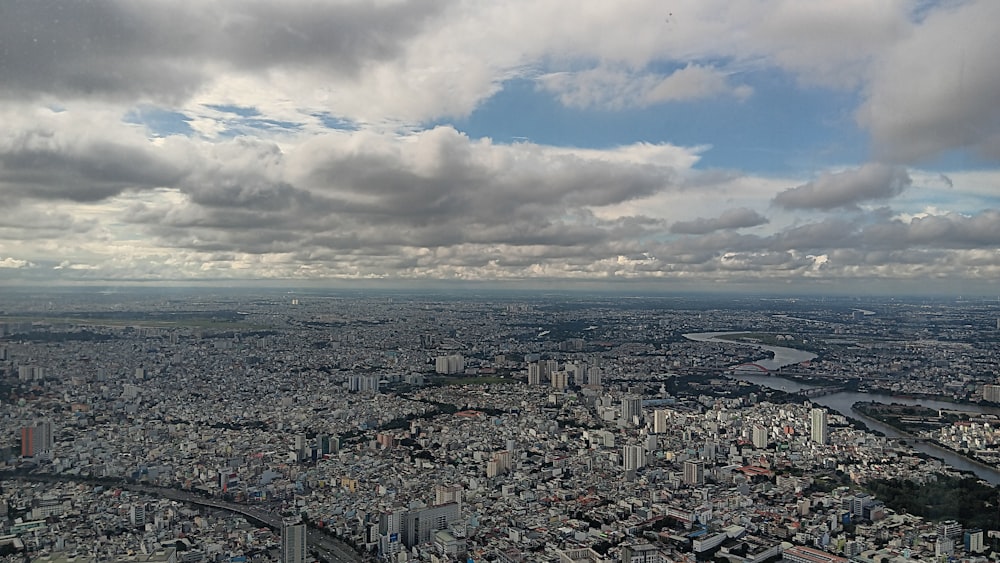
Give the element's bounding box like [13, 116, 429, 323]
[0, 0, 1000, 295]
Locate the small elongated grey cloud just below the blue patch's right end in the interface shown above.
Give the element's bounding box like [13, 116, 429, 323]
[773, 164, 912, 210]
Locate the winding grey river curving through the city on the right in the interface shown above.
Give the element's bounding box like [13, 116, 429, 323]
[684, 332, 1000, 485]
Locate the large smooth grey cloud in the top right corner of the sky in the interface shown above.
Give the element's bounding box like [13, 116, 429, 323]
[857, 0, 1000, 163]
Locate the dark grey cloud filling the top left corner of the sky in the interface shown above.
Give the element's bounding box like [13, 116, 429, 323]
[0, 0, 444, 101]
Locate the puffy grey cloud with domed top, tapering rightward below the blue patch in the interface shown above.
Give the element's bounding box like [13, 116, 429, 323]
[294, 128, 675, 231]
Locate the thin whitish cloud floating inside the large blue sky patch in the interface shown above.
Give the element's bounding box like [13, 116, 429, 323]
[538, 64, 753, 110]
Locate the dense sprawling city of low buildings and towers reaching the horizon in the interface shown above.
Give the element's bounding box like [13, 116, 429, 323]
[0, 288, 1000, 563]
